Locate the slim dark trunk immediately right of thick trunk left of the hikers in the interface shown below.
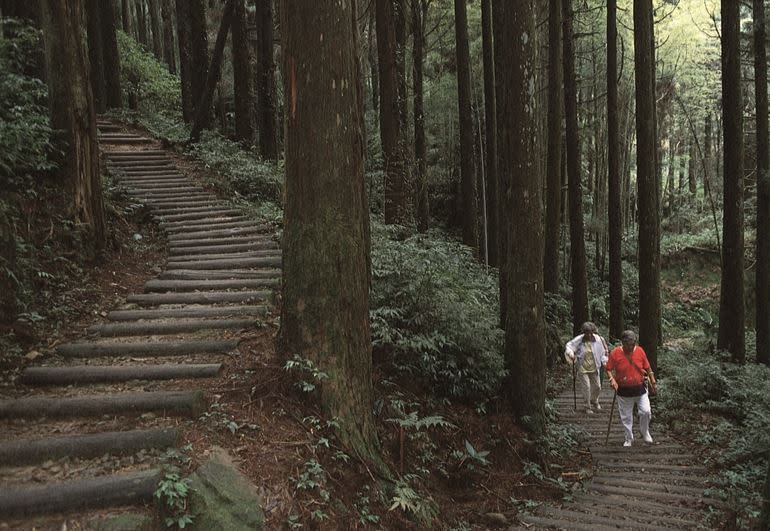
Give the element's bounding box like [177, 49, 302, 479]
[543, 0, 563, 293]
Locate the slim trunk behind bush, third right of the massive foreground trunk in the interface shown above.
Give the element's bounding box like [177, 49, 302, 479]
[455, 0, 479, 252]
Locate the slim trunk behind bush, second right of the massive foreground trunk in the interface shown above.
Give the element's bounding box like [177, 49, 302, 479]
[412, 0, 430, 231]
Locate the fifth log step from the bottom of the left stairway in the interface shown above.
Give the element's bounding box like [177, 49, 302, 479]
[56, 341, 238, 358]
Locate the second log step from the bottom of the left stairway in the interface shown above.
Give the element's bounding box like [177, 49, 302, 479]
[0, 428, 179, 466]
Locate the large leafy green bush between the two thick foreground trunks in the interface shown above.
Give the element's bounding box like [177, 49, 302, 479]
[370, 224, 505, 400]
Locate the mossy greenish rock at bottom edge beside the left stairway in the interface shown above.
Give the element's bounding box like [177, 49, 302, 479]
[189, 447, 265, 531]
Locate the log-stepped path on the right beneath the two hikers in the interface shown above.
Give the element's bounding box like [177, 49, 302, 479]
[520, 382, 722, 531]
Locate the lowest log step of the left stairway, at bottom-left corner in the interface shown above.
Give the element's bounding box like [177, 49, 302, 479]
[0, 470, 162, 518]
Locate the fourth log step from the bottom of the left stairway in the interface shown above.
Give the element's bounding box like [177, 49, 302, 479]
[21, 363, 222, 385]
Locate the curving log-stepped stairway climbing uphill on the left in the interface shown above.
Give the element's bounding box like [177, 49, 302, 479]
[0, 121, 281, 529]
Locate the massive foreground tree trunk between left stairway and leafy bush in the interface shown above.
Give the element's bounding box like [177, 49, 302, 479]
[280, 0, 380, 462]
